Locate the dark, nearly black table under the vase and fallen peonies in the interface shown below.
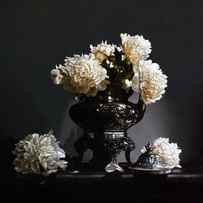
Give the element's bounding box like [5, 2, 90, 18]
[3, 164, 203, 203]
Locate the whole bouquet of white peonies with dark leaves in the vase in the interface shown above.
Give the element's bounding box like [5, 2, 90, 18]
[51, 34, 167, 104]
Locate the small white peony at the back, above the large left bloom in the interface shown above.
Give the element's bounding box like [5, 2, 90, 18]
[90, 41, 116, 62]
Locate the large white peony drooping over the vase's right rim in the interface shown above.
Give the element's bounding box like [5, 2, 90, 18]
[135, 60, 167, 104]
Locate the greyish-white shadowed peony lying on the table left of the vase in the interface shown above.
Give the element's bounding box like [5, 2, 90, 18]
[14, 131, 67, 175]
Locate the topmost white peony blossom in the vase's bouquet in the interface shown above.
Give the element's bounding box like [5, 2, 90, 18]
[120, 33, 151, 64]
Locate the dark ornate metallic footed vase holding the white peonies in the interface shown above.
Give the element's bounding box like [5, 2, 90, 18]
[69, 88, 146, 172]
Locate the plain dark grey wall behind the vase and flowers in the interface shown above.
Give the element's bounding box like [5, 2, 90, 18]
[0, 0, 203, 180]
